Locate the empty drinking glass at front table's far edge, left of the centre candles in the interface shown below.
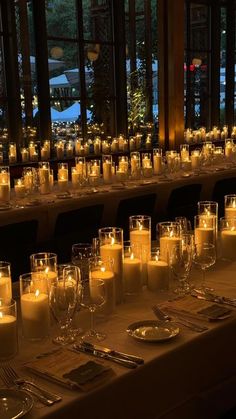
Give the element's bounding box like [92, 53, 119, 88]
[71, 243, 93, 282]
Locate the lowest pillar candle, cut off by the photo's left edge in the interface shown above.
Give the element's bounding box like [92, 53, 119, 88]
[0, 311, 18, 360]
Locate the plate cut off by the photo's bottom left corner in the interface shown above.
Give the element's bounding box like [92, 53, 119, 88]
[0, 388, 34, 419]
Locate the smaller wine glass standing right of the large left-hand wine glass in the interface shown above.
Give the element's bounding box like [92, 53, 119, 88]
[80, 278, 106, 341]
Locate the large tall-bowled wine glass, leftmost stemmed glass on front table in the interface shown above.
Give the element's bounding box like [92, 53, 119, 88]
[49, 271, 81, 345]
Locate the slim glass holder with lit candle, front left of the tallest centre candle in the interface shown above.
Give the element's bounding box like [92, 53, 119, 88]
[123, 244, 142, 295]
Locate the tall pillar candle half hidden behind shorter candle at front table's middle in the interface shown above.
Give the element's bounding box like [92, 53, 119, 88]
[100, 243, 123, 304]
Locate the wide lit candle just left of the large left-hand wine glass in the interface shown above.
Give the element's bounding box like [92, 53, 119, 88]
[20, 290, 50, 339]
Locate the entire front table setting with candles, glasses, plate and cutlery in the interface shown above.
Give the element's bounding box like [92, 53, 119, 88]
[0, 196, 236, 419]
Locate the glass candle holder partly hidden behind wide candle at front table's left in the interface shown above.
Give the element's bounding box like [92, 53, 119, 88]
[30, 252, 57, 286]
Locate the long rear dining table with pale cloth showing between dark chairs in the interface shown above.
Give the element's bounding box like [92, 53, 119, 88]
[0, 166, 236, 243]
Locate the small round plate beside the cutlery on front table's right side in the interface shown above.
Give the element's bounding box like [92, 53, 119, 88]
[126, 320, 179, 342]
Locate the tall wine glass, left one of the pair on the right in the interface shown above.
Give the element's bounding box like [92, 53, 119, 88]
[168, 233, 193, 295]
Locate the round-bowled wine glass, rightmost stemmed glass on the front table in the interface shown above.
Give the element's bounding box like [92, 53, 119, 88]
[193, 243, 216, 291]
